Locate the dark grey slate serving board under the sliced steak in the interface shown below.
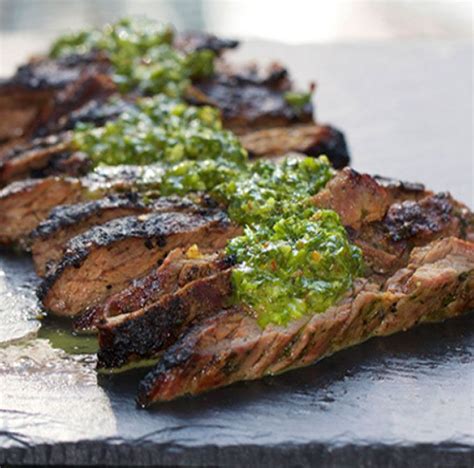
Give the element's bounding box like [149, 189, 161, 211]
[0, 42, 474, 467]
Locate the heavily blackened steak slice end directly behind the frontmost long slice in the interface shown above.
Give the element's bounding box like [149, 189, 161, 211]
[97, 269, 232, 368]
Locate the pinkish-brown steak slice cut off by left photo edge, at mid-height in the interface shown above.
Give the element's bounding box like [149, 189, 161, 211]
[0, 177, 82, 245]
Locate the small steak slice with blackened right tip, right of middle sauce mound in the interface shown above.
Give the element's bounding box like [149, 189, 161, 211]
[240, 123, 350, 169]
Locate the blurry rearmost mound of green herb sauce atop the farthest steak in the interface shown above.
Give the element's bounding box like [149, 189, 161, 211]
[49, 18, 215, 97]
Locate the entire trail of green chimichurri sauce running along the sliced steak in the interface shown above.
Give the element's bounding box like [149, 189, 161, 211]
[51, 20, 362, 327]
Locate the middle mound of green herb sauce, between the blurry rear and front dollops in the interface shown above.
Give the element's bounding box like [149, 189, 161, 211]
[73, 96, 247, 165]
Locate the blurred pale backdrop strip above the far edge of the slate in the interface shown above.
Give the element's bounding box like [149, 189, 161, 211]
[0, 0, 472, 75]
